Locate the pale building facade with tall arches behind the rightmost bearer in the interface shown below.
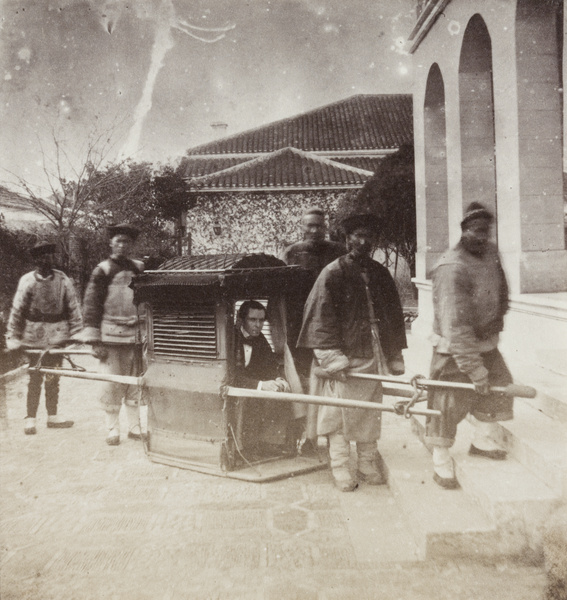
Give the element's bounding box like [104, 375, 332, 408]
[409, 0, 567, 374]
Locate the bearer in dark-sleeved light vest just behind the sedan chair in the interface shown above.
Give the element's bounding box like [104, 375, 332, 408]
[82, 223, 145, 446]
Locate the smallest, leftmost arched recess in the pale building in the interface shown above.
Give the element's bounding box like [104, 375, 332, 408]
[424, 63, 449, 253]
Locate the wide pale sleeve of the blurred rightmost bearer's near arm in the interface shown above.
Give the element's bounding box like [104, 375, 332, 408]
[433, 262, 488, 381]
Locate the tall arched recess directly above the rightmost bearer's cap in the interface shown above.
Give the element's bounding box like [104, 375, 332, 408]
[459, 14, 498, 241]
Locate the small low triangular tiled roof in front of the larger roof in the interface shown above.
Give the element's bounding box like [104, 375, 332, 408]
[189, 148, 372, 192]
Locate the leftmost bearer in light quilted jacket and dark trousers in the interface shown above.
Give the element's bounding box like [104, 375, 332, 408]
[6, 243, 83, 435]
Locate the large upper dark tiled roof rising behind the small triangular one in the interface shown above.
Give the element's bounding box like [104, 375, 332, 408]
[187, 94, 413, 156]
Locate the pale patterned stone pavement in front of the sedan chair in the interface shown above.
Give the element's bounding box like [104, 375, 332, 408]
[0, 360, 545, 600]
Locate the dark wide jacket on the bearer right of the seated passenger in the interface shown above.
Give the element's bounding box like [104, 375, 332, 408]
[297, 254, 407, 360]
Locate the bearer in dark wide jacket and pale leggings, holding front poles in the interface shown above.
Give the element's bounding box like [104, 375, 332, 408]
[298, 213, 407, 492]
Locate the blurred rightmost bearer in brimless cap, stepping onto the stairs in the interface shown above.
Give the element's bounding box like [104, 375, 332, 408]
[426, 202, 513, 489]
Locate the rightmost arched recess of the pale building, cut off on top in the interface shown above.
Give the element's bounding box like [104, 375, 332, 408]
[516, 0, 565, 253]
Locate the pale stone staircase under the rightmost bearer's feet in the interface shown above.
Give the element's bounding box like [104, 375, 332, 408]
[379, 336, 567, 563]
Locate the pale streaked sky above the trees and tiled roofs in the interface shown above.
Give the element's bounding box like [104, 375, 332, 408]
[0, 0, 415, 188]
